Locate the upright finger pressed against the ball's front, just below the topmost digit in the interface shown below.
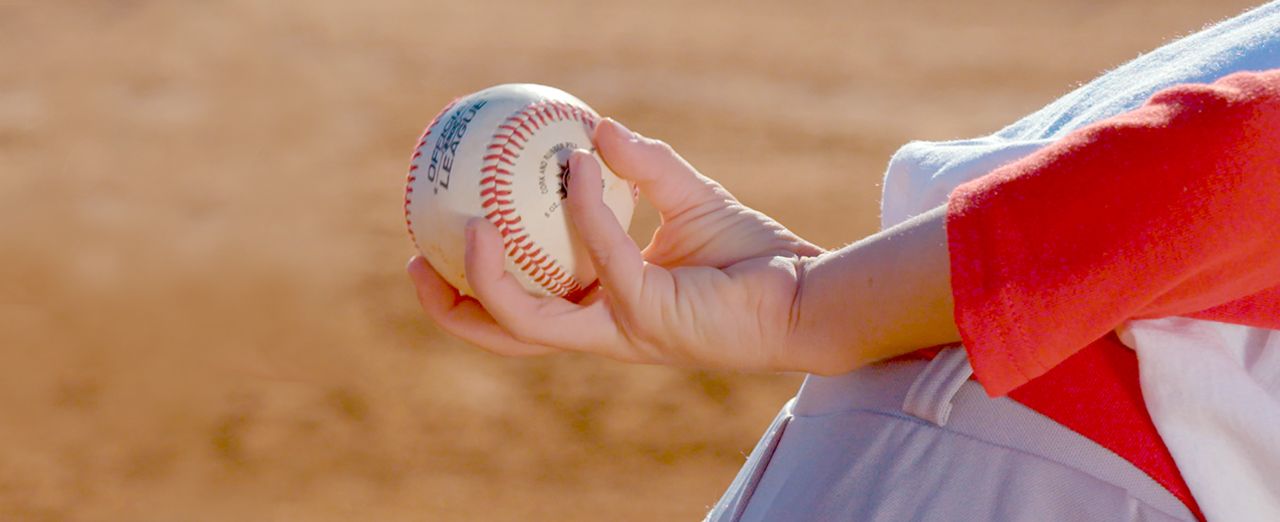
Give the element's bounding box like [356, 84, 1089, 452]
[567, 150, 644, 303]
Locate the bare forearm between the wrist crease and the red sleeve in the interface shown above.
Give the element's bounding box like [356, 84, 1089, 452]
[790, 206, 960, 375]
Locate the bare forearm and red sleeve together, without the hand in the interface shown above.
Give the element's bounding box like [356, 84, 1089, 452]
[792, 72, 1280, 381]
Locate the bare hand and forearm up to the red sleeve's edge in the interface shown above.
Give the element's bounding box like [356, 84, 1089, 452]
[408, 120, 959, 374]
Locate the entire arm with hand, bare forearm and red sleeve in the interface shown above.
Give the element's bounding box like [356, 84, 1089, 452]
[410, 73, 1280, 383]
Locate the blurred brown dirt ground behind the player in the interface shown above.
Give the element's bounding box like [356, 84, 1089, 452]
[0, 0, 1251, 521]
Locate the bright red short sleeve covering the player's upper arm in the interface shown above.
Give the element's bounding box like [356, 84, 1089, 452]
[947, 69, 1280, 395]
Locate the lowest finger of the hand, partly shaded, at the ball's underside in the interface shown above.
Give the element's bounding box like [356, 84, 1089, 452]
[406, 256, 557, 357]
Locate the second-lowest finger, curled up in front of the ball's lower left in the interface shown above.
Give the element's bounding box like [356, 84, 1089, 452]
[466, 214, 618, 352]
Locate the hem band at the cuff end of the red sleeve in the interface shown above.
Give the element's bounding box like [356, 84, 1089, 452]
[946, 182, 1048, 397]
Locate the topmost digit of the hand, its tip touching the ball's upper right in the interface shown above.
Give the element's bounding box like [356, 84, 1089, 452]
[595, 118, 718, 215]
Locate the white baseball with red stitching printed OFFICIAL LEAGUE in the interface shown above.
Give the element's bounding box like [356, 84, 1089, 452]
[404, 83, 635, 298]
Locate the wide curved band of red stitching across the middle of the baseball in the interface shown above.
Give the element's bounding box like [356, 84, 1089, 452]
[480, 100, 596, 297]
